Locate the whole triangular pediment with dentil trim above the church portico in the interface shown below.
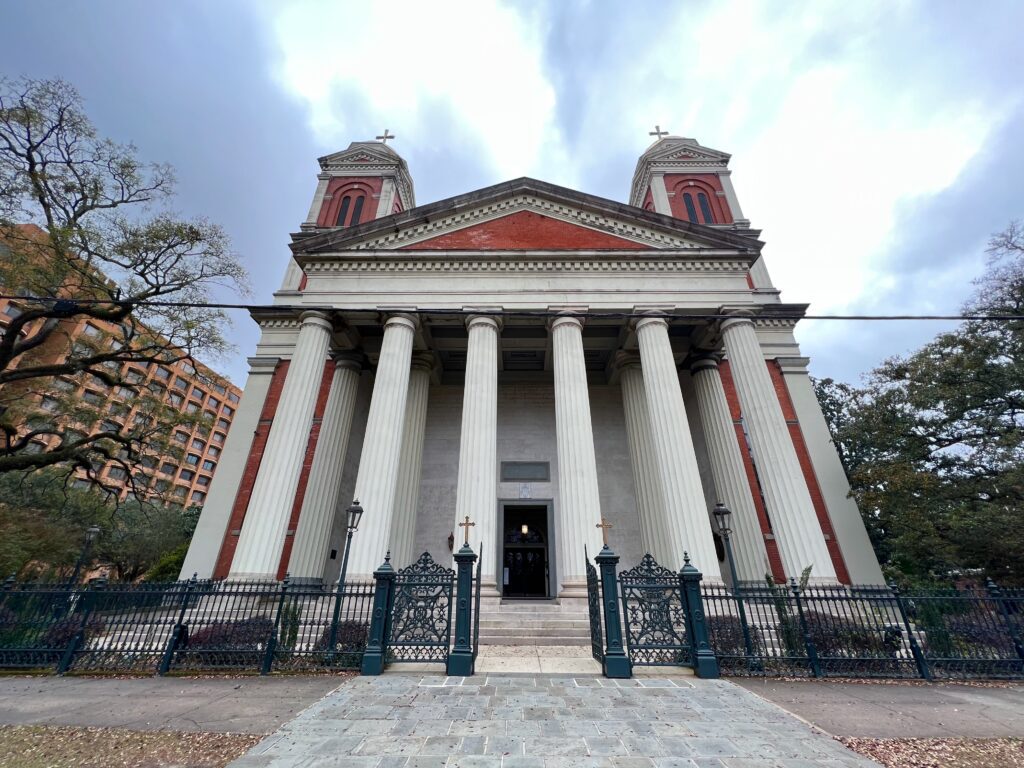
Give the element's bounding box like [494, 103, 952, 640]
[292, 178, 761, 254]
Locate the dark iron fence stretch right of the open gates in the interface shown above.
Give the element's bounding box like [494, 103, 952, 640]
[702, 583, 1024, 679]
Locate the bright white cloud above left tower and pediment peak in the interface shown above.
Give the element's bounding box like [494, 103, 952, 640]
[272, 0, 560, 183]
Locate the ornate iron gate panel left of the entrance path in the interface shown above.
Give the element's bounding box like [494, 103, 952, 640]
[387, 552, 455, 663]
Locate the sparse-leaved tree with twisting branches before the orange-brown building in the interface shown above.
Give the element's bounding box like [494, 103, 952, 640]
[0, 78, 246, 496]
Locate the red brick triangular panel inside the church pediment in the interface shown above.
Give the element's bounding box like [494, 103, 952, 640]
[401, 211, 649, 251]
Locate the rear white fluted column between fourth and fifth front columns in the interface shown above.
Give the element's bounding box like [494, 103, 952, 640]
[617, 352, 667, 562]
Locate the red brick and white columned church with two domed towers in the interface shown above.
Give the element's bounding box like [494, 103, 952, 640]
[182, 133, 883, 598]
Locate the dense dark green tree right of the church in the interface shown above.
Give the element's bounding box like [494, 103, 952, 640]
[816, 223, 1024, 585]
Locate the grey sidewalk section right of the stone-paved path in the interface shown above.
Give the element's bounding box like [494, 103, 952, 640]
[733, 678, 1024, 738]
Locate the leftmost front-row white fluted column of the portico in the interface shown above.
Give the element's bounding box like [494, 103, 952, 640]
[227, 312, 332, 580]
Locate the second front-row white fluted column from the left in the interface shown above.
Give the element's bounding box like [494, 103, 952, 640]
[347, 314, 416, 581]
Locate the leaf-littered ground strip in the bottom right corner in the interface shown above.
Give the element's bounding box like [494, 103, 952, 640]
[839, 738, 1024, 768]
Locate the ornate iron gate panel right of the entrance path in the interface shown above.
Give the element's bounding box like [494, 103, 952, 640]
[618, 554, 693, 666]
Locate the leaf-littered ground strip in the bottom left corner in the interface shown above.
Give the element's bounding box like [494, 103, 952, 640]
[0, 725, 263, 768]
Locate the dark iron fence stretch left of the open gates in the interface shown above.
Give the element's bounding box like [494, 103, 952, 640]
[0, 580, 373, 674]
